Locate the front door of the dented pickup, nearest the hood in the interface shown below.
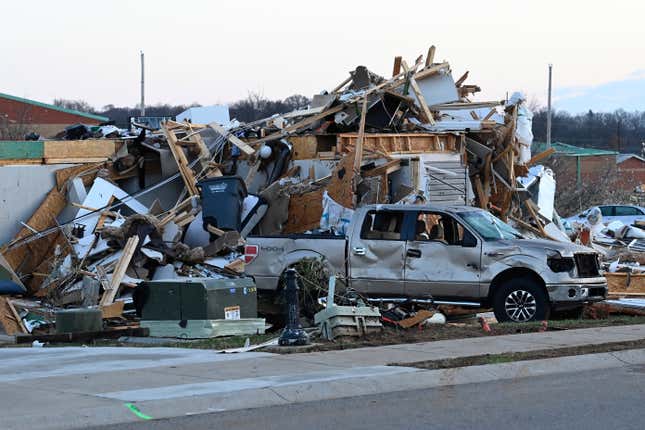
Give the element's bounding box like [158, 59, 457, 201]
[404, 211, 482, 299]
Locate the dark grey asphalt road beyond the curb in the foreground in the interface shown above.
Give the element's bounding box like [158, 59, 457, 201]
[92, 366, 645, 430]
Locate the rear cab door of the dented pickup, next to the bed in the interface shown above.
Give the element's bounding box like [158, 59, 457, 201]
[349, 210, 409, 296]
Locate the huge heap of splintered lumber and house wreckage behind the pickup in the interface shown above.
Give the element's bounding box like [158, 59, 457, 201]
[0, 46, 580, 340]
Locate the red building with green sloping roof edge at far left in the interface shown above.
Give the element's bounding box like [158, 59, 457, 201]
[0, 93, 109, 137]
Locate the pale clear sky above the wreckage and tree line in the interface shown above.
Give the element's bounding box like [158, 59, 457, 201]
[0, 0, 645, 112]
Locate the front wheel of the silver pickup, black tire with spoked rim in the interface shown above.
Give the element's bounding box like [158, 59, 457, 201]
[493, 277, 550, 322]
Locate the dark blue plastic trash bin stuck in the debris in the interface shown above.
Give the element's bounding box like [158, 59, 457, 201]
[197, 176, 248, 231]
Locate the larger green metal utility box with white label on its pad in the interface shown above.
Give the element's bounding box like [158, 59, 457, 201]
[140, 278, 265, 338]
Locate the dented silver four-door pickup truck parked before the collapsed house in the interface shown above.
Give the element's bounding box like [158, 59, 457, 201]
[245, 205, 607, 322]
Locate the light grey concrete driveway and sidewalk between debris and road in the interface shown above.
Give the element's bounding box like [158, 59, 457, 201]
[0, 325, 645, 429]
